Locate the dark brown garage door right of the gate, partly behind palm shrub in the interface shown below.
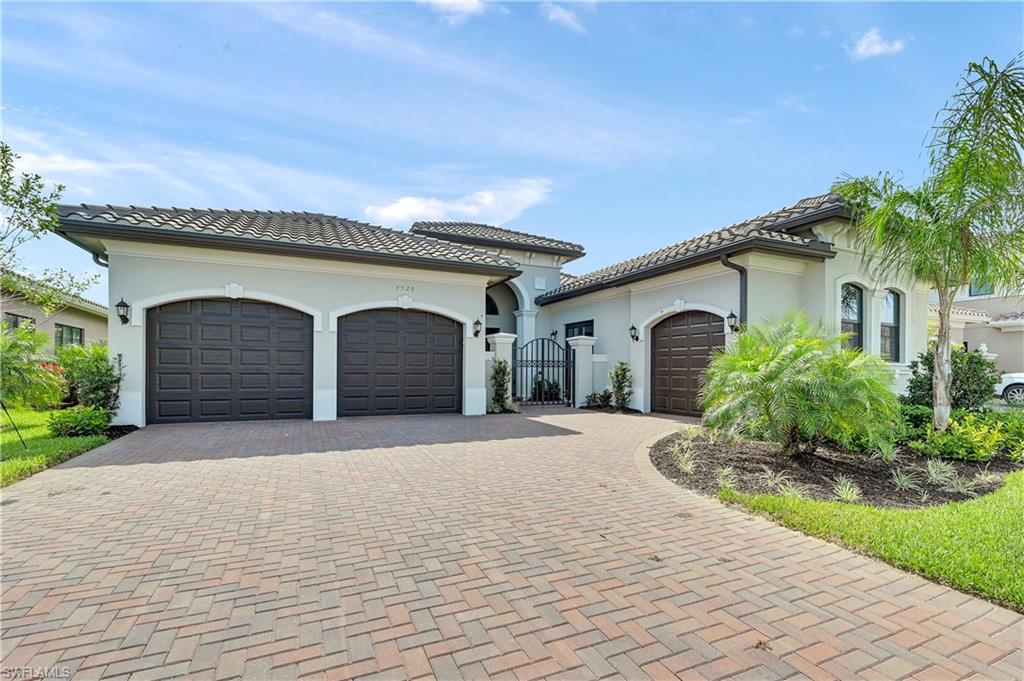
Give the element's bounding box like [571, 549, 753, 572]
[650, 311, 725, 416]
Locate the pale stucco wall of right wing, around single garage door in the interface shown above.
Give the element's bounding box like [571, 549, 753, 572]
[537, 221, 928, 412]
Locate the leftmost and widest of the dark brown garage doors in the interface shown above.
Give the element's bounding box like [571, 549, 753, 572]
[145, 298, 313, 423]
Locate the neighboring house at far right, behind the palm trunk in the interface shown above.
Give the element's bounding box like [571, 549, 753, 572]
[929, 284, 1024, 373]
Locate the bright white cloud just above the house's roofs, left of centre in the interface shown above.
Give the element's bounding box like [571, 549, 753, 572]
[364, 177, 553, 226]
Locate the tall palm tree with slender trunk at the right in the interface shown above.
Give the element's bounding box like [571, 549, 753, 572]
[835, 58, 1024, 430]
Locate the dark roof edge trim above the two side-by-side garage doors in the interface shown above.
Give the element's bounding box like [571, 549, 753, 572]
[56, 218, 520, 275]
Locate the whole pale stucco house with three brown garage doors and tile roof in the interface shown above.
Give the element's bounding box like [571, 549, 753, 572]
[58, 195, 928, 425]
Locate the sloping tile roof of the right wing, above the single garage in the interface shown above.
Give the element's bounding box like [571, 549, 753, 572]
[537, 194, 842, 304]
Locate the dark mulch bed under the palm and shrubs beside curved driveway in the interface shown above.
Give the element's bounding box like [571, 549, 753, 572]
[650, 433, 1024, 508]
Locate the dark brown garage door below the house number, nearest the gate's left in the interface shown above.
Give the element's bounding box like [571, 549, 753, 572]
[338, 309, 462, 416]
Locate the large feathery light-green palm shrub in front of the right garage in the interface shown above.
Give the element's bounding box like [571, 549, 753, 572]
[701, 312, 899, 455]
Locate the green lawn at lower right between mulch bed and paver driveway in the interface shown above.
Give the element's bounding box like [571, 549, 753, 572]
[720, 471, 1024, 612]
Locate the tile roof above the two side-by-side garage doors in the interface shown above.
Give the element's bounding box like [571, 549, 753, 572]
[58, 204, 517, 272]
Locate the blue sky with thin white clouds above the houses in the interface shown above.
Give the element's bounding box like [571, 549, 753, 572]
[2, 2, 1024, 300]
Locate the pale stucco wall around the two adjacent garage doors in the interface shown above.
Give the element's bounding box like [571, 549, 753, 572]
[105, 241, 487, 425]
